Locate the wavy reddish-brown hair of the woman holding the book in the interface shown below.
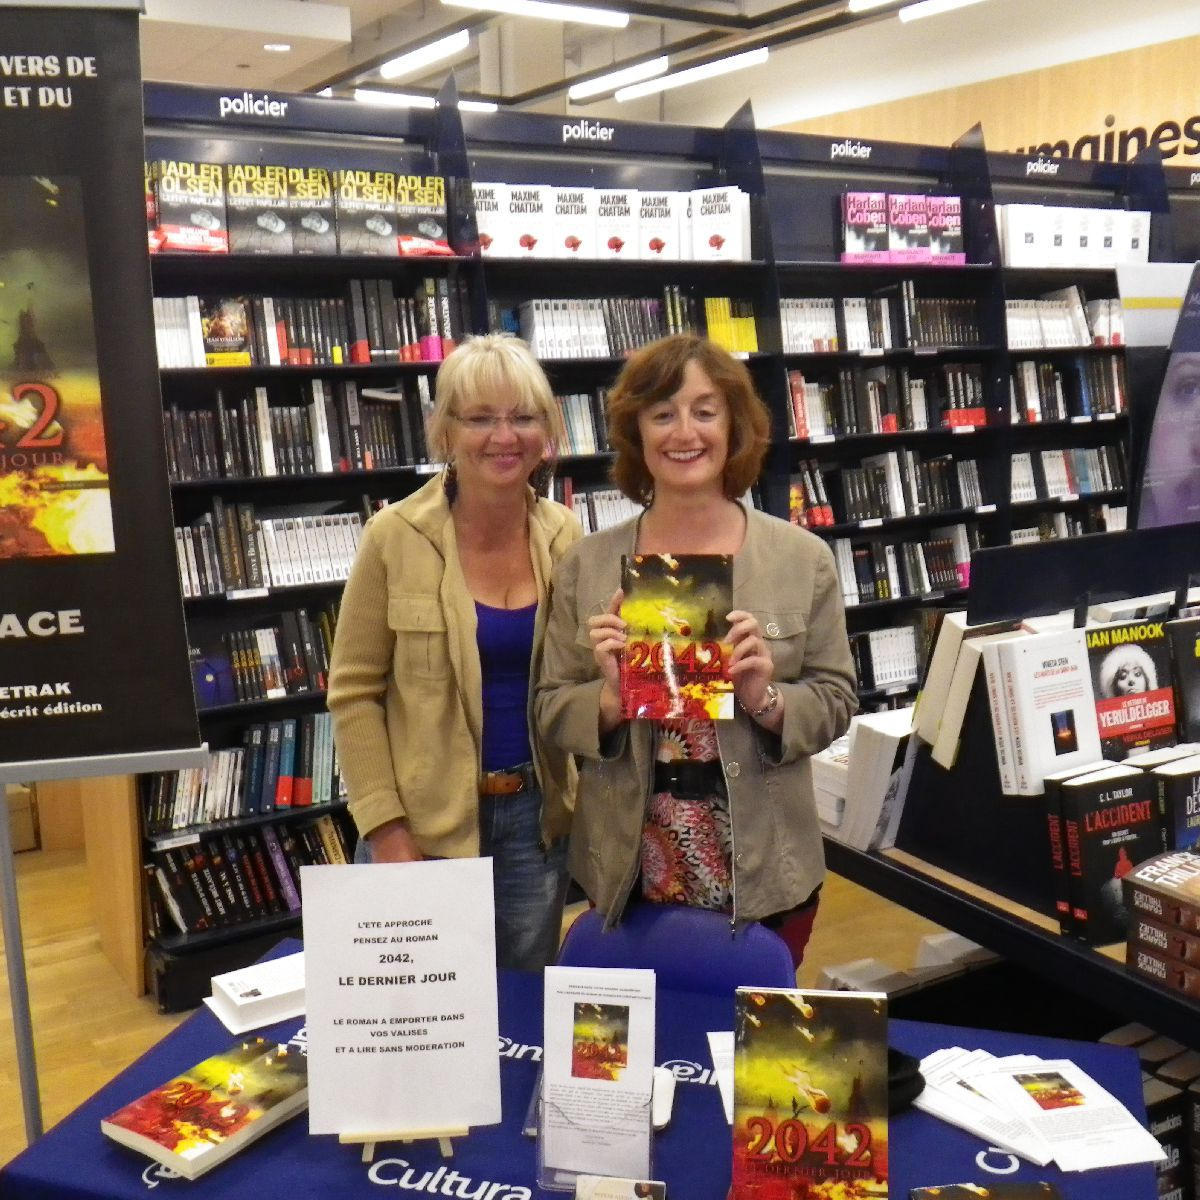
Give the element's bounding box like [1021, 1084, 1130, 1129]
[607, 334, 770, 504]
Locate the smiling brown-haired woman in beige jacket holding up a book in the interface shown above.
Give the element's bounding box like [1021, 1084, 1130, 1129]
[536, 336, 856, 964]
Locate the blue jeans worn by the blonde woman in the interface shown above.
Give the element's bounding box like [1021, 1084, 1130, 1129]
[354, 787, 568, 971]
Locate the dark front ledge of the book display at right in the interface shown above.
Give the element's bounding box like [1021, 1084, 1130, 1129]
[826, 838, 1200, 1045]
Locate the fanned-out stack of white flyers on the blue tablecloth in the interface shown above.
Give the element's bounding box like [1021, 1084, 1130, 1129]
[913, 1046, 1165, 1171]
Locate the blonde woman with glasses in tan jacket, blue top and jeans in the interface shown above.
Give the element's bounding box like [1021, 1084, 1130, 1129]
[329, 334, 581, 970]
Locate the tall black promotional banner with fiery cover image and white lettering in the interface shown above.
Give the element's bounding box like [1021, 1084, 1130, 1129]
[0, 7, 199, 763]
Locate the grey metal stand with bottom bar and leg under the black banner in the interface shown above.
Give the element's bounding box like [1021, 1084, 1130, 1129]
[0, 744, 209, 1142]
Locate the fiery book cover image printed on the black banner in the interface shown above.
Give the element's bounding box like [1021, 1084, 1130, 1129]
[0, 175, 115, 560]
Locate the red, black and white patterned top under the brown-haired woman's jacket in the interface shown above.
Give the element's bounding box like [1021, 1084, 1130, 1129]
[642, 719, 733, 912]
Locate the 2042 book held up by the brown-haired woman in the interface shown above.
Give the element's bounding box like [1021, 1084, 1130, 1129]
[620, 554, 733, 720]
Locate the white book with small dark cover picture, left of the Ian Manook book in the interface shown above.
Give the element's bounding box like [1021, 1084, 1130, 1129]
[1000, 629, 1102, 796]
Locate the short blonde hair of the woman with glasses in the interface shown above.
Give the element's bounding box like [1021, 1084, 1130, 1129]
[427, 334, 558, 460]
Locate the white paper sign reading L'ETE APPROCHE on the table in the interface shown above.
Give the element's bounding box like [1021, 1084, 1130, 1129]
[300, 858, 500, 1134]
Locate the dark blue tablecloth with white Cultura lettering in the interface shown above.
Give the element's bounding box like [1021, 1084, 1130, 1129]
[0, 943, 1156, 1200]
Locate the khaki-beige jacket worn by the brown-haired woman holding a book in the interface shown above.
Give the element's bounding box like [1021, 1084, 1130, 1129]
[536, 510, 857, 924]
